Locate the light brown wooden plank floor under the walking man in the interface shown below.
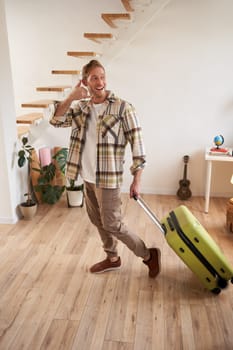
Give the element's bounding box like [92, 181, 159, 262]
[0, 195, 233, 350]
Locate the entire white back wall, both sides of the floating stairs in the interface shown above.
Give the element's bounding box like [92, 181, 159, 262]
[6, 0, 233, 205]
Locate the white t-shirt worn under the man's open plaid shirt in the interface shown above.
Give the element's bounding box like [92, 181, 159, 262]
[80, 103, 104, 183]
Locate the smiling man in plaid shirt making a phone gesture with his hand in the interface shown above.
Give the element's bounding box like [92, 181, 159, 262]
[50, 60, 160, 278]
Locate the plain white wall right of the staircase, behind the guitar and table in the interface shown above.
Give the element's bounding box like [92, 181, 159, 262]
[106, 0, 233, 195]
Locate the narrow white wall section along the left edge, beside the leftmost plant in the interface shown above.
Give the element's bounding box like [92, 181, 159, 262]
[0, 0, 17, 224]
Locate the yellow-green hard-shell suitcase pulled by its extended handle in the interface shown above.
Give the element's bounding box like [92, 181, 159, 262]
[134, 197, 233, 294]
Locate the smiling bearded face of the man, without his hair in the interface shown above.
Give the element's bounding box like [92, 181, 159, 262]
[84, 67, 106, 99]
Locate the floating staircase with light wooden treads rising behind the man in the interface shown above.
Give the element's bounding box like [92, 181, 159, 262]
[16, 0, 158, 137]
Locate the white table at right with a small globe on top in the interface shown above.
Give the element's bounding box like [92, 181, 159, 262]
[205, 148, 233, 213]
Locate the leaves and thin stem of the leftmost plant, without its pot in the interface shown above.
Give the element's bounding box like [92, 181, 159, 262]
[18, 137, 36, 207]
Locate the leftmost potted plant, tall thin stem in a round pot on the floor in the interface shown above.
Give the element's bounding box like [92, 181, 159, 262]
[18, 137, 37, 219]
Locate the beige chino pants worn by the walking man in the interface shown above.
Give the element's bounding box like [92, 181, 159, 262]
[84, 182, 149, 258]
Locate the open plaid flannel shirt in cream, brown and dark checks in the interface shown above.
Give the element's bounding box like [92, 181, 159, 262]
[50, 92, 146, 188]
